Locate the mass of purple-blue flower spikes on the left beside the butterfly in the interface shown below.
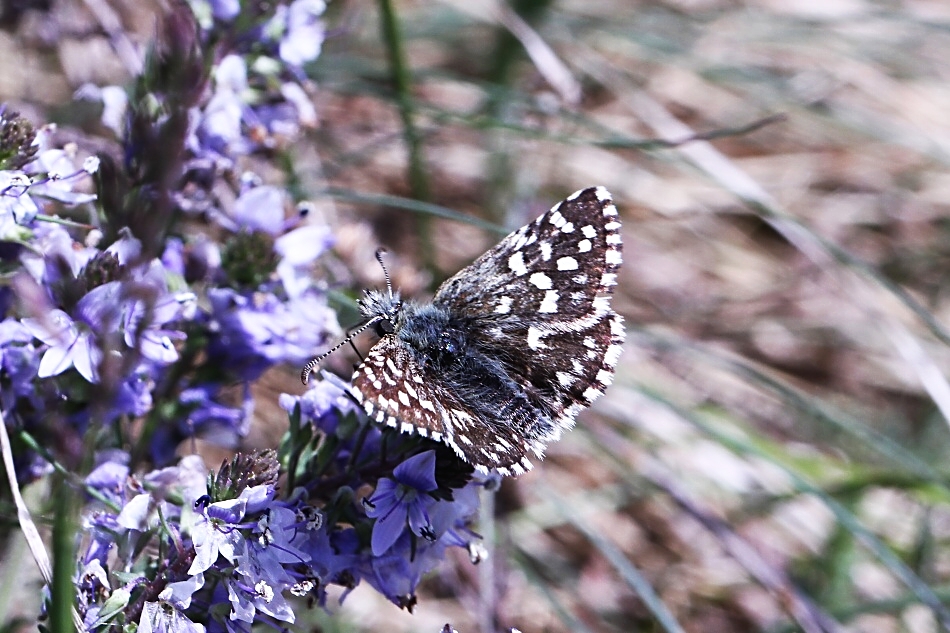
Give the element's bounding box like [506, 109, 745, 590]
[0, 0, 495, 631]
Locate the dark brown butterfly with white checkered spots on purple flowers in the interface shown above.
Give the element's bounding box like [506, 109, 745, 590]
[301, 187, 626, 475]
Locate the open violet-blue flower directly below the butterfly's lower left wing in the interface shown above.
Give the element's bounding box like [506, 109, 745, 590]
[363, 450, 438, 556]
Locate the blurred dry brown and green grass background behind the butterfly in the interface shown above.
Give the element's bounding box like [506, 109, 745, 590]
[0, 0, 950, 633]
